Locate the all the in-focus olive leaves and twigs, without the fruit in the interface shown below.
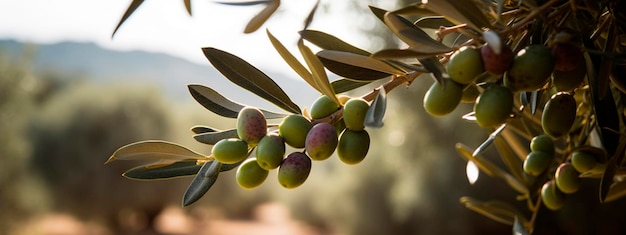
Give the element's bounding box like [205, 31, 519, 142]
[109, 0, 626, 234]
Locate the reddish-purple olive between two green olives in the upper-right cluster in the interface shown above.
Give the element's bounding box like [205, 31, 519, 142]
[480, 43, 513, 75]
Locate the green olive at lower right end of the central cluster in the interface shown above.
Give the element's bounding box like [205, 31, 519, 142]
[337, 129, 370, 165]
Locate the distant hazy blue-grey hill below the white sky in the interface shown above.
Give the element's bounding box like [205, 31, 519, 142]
[0, 40, 318, 110]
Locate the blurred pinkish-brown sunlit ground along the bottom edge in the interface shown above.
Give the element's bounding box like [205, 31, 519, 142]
[15, 203, 328, 235]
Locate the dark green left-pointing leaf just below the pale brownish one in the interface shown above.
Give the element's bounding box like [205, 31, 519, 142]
[122, 160, 202, 180]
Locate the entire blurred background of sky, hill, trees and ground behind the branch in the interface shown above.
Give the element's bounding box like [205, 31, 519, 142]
[0, 0, 621, 234]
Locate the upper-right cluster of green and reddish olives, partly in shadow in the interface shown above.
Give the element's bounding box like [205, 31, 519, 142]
[424, 39, 586, 129]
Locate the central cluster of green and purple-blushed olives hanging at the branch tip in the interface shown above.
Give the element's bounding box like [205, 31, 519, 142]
[212, 96, 370, 189]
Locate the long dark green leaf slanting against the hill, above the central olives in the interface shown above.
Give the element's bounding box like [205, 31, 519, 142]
[202, 47, 301, 113]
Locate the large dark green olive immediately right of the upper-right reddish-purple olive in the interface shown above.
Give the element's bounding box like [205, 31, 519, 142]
[504, 45, 555, 91]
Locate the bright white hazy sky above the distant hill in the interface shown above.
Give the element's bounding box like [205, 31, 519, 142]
[0, 0, 386, 75]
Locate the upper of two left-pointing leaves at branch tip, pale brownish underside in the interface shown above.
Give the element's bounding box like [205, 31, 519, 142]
[105, 140, 207, 164]
